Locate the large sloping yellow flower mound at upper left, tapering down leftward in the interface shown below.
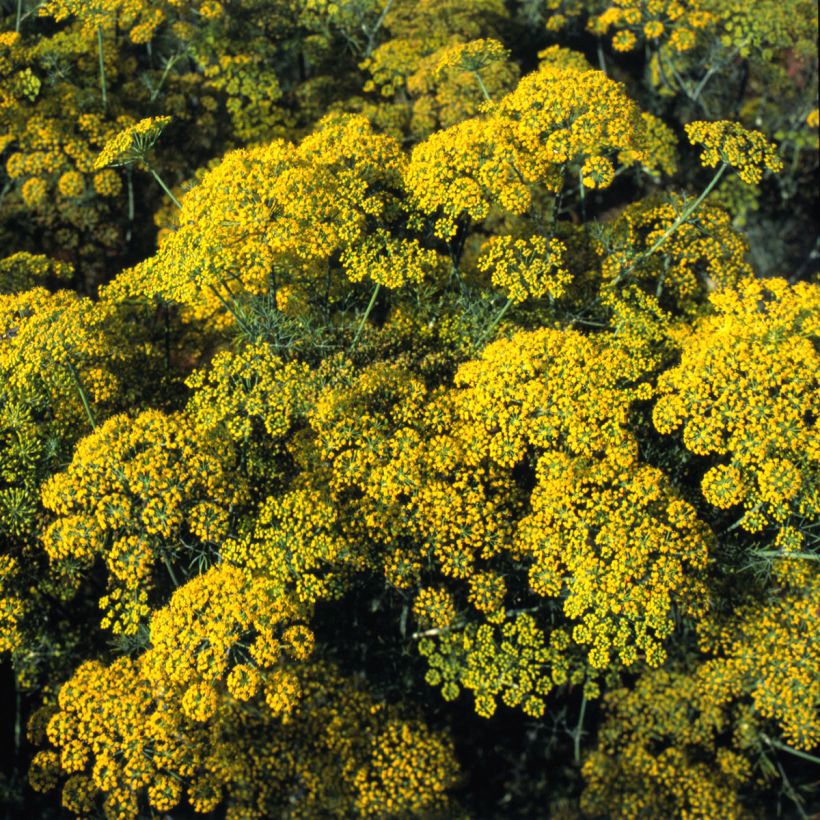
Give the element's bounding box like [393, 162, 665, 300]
[107, 116, 414, 322]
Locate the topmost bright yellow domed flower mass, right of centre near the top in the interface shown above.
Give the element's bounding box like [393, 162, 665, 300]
[407, 63, 664, 238]
